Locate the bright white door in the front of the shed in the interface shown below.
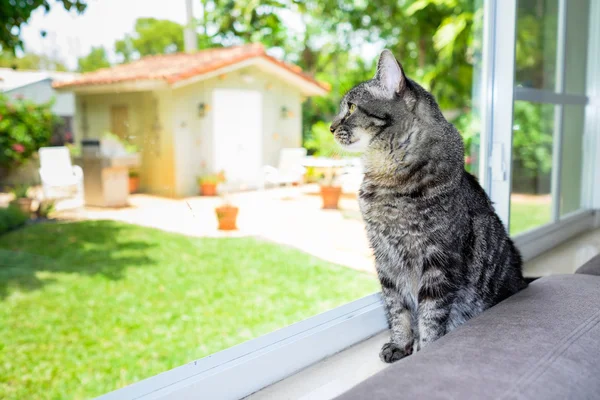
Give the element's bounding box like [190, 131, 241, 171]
[213, 89, 262, 186]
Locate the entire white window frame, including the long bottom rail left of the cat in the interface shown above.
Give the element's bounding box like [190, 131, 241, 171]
[99, 0, 600, 400]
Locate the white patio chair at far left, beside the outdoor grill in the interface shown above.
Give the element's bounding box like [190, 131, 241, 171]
[39, 147, 84, 209]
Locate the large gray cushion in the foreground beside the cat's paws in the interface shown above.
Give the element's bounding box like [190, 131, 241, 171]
[338, 275, 600, 400]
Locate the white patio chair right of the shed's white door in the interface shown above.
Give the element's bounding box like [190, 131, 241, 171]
[261, 147, 306, 188]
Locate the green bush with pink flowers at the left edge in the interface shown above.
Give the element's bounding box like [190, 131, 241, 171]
[0, 94, 60, 170]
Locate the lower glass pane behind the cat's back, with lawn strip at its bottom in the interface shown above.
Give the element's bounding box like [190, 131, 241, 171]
[510, 101, 555, 235]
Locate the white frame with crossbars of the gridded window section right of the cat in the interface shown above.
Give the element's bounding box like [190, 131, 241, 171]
[482, 0, 600, 261]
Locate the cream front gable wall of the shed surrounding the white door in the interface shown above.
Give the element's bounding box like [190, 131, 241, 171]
[173, 67, 302, 196]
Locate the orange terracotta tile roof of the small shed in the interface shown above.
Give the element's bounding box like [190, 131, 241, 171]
[54, 44, 329, 90]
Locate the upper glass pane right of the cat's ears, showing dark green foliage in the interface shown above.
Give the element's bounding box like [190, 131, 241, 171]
[515, 0, 558, 91]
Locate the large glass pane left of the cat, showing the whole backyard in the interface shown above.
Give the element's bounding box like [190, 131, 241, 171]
[0, 0, 483, 399]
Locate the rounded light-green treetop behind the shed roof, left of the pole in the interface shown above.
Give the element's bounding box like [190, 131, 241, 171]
[115, 18, 183, 62]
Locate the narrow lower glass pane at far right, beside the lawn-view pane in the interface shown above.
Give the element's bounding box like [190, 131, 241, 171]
[560, 105, 585, 216]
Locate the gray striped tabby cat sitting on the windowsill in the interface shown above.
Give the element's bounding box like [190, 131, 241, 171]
[330, 50, 527, 362]
